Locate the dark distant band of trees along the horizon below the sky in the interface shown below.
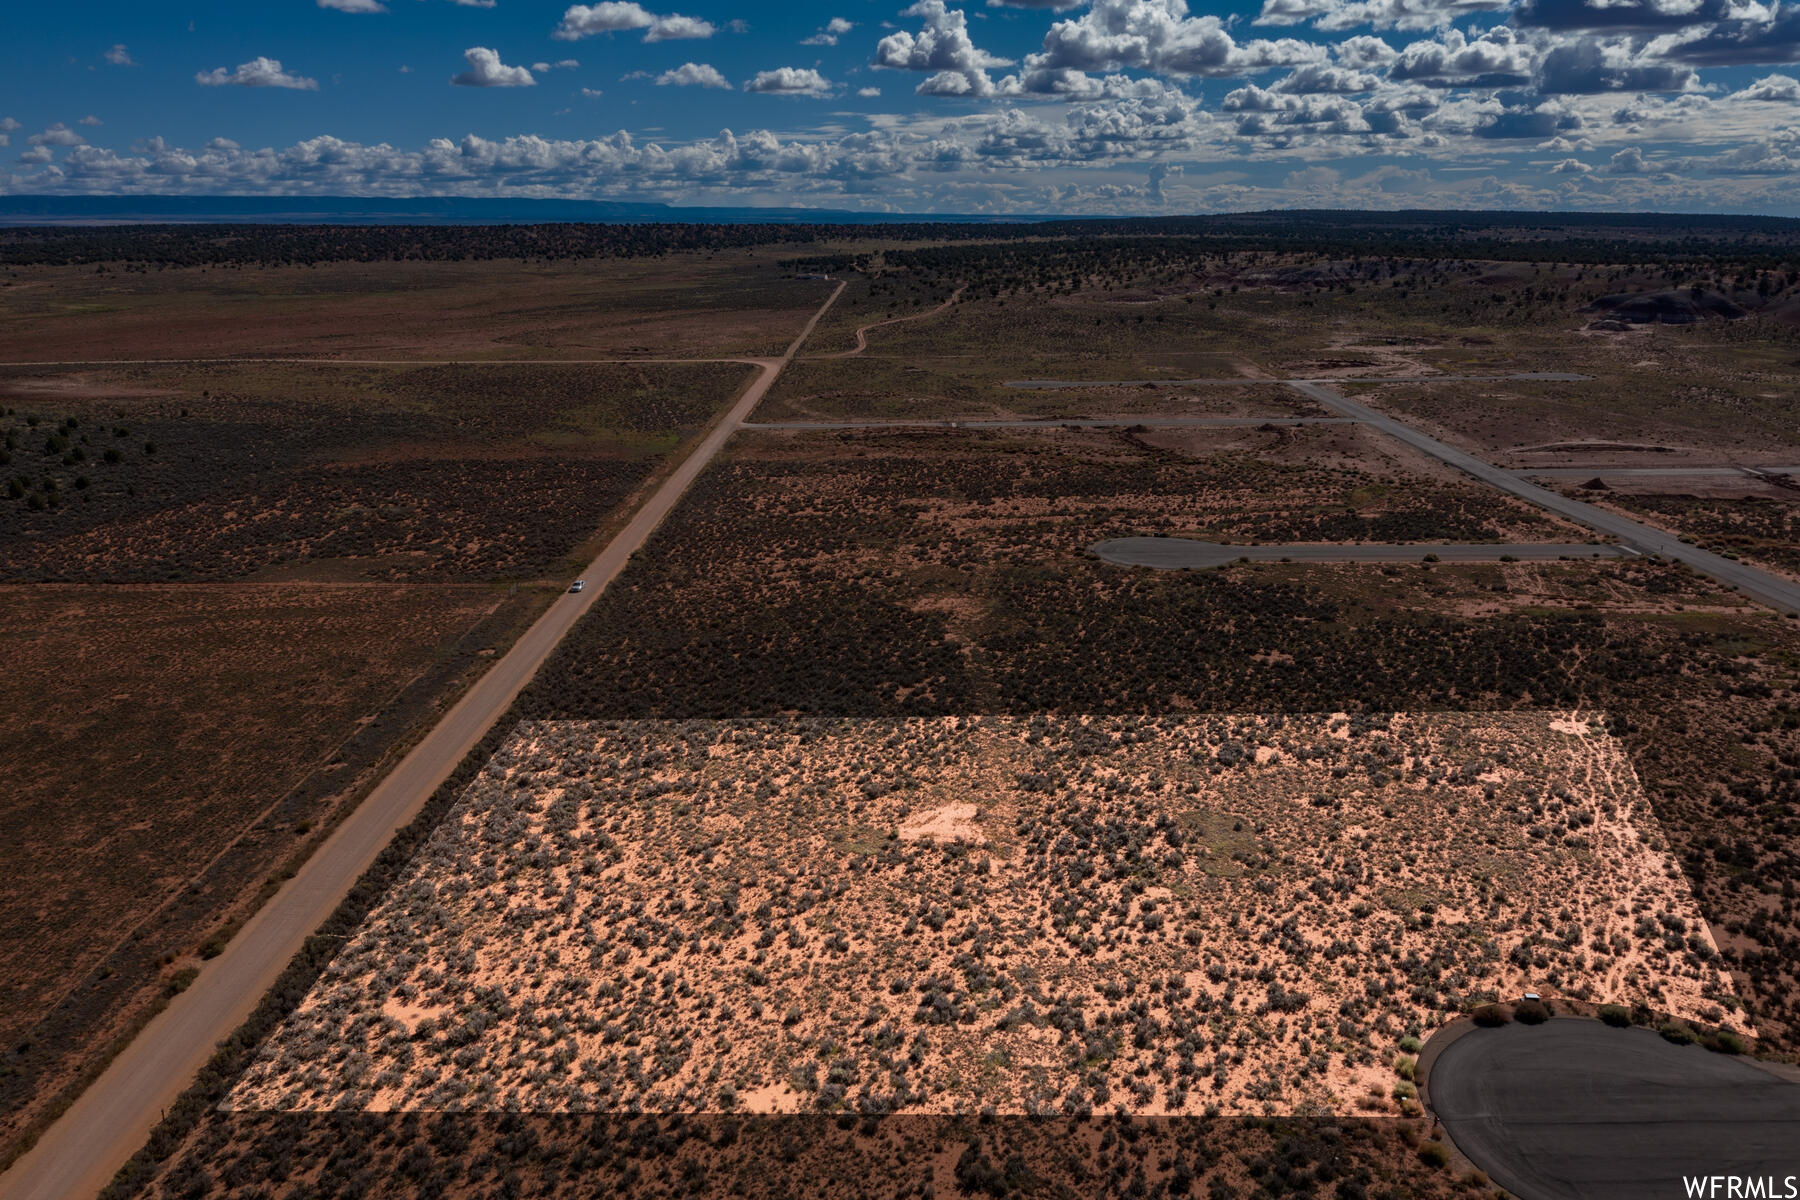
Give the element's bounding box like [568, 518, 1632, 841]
[0, 210, 1800, 270]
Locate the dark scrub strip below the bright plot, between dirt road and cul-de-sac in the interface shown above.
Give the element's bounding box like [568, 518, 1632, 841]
[130, 1115, 1458, 1200]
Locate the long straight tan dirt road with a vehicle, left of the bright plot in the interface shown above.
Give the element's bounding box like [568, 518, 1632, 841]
[0, 284, 844, 1200]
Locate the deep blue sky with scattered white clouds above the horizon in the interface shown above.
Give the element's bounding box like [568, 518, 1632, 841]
[0, 0, 1800, 214]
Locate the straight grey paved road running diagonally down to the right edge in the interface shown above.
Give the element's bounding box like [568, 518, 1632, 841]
[1287, 381, 1800, 612]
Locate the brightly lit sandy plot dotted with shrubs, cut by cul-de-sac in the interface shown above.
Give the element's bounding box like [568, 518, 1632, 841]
[229, 712, 1735, 1115]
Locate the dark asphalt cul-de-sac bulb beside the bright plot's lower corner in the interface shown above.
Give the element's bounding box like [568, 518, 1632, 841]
[1429, 1018, 1800, 1200]
